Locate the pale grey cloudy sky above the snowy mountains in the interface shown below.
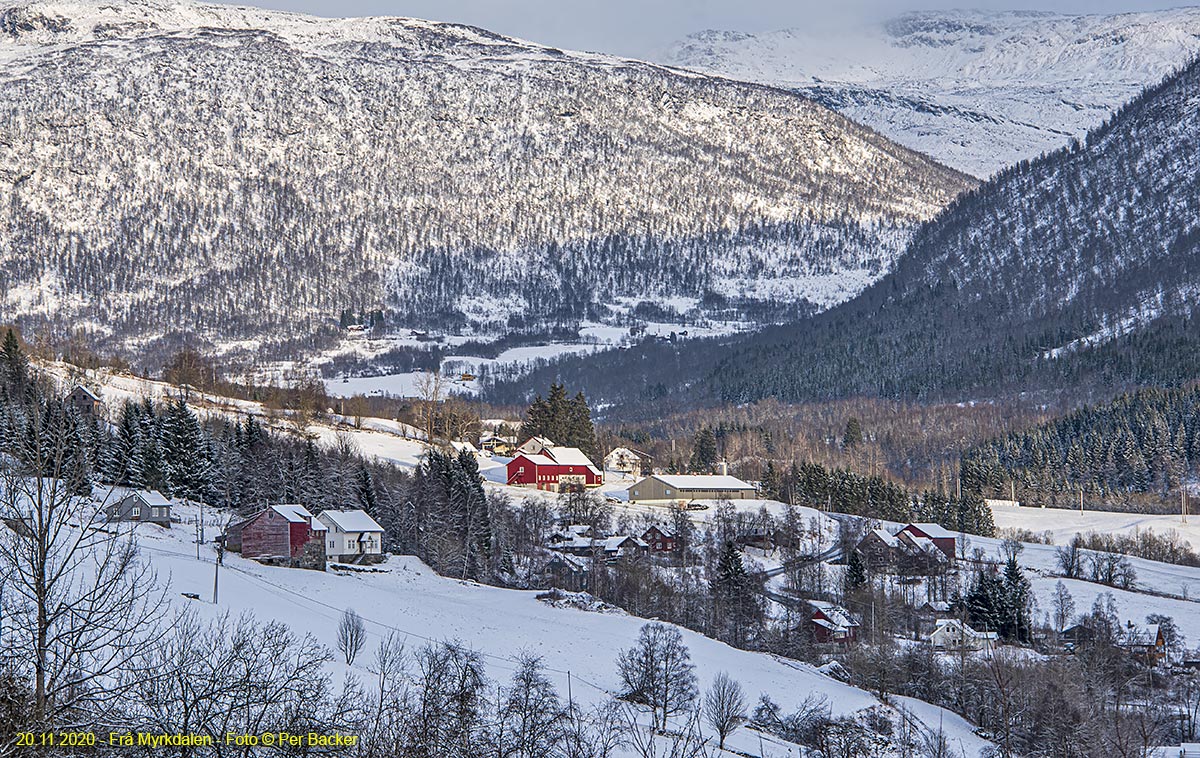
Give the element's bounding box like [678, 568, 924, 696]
[211, 0, 1196, 59]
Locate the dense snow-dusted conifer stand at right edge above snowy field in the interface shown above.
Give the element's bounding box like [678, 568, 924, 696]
[961, 385, 1200, 509]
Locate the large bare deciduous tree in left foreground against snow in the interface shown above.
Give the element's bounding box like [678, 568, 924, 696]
[0, 397, 166, 729]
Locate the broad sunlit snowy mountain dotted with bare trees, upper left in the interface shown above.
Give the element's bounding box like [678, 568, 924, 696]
[0, 0, 972, 362]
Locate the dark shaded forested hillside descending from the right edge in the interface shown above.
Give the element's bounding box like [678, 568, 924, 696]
[511, 57, 1200, 414]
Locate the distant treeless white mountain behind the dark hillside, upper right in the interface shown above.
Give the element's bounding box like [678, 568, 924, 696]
[662, 7, 1200, 178]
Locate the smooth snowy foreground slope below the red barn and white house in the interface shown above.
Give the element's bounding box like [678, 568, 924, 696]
[137, 506, 986, 758]
